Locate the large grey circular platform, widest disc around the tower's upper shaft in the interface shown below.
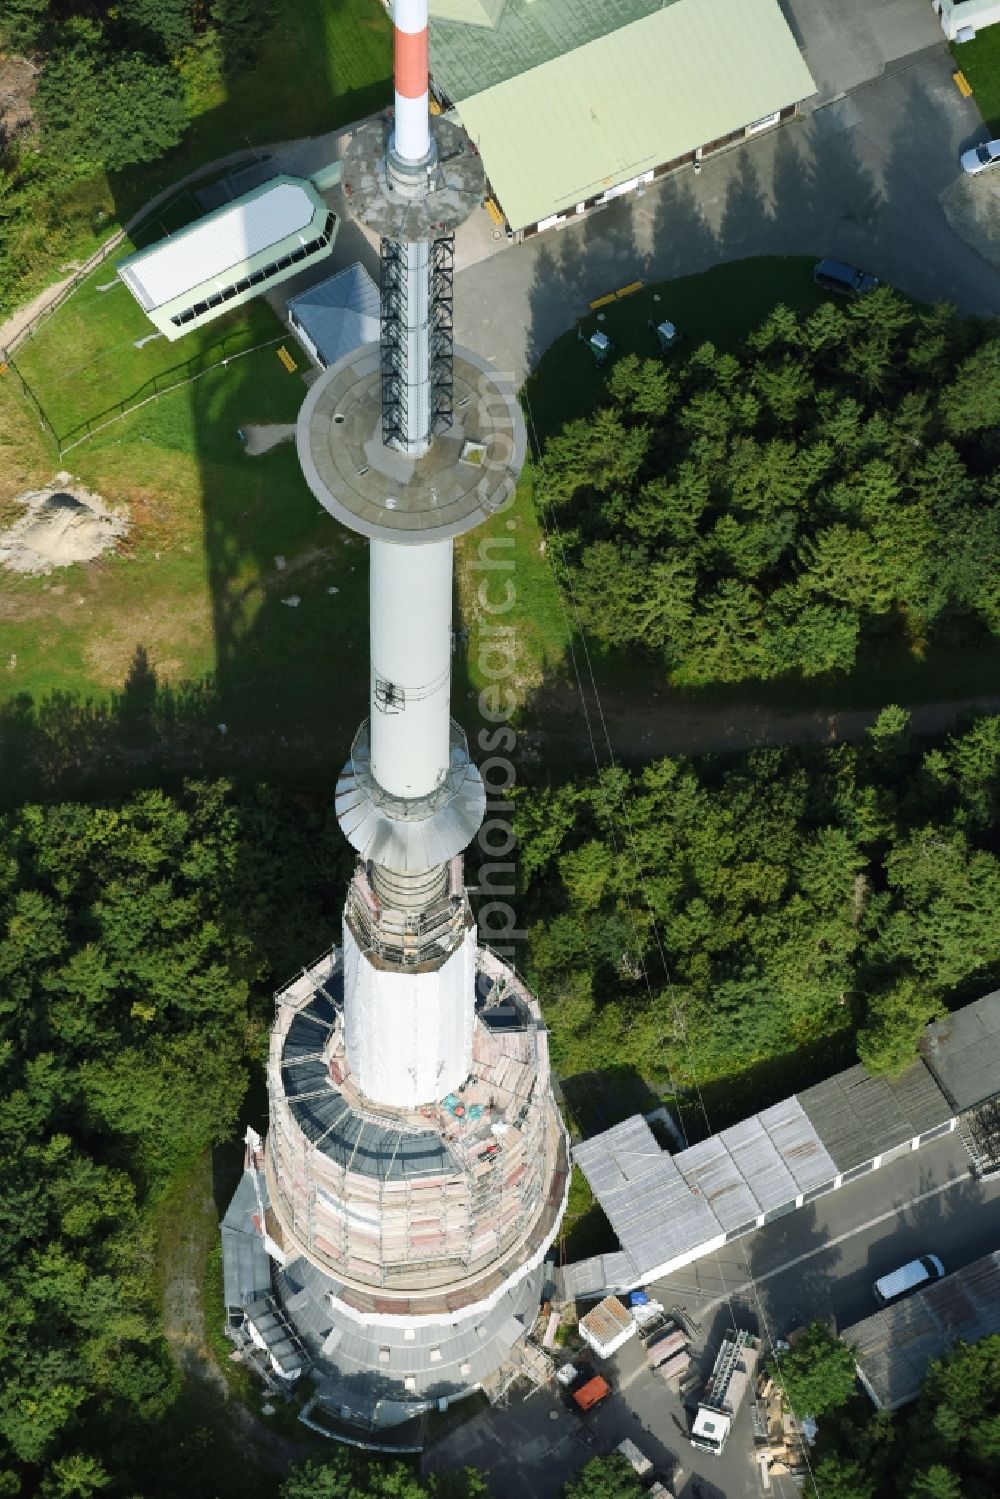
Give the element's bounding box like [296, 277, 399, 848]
[295, 343, 528, 544]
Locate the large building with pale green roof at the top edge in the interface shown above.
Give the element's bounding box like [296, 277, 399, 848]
[430, 0, 816, 234]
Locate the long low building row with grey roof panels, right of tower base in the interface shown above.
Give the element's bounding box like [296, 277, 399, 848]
[562, 991, 1000, 1298]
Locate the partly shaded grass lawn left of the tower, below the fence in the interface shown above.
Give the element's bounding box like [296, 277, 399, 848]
[0, 306, 367, 796]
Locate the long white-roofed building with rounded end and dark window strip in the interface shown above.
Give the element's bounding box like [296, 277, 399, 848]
[117, 177, 337, 340]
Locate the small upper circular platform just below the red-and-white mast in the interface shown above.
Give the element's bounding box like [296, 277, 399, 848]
[340, 115, 486, 243]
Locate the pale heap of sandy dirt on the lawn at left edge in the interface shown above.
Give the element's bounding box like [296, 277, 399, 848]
[0, 474, 129, 576]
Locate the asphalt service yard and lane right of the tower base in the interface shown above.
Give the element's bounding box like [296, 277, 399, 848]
[426, 1135, 1000, 1499]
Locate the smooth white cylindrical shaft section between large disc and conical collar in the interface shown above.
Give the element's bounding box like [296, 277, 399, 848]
[370, 541, 451, 799]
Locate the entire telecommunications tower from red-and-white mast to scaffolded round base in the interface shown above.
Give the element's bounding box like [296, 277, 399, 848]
[223, 0, 570, 1435]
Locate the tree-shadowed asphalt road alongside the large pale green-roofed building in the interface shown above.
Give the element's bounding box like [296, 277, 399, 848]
[454, 41, 1000, 384]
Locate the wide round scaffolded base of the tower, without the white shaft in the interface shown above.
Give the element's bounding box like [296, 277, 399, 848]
[222, 947, 568, 1433]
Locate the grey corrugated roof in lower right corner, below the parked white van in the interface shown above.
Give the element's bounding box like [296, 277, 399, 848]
[841, 1250, 1000, 1411]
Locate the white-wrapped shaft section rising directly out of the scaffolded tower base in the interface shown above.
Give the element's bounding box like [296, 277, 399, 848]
[343, 922, 475, 1109]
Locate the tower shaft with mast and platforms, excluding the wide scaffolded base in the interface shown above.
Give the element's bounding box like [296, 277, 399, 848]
[298, 0, 525, 1109]
